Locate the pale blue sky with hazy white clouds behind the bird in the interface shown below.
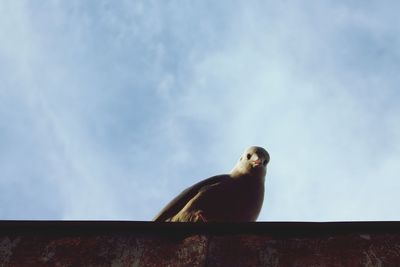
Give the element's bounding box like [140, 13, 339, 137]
[0, 0, 400, 221]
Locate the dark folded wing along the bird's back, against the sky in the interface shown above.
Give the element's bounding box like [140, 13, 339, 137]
[153, 175, 229, 222]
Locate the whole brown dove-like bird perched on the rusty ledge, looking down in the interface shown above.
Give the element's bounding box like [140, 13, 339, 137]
[154, 147, 269, 222]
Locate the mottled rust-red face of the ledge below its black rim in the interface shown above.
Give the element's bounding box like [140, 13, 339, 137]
[0, 224, 400, 267]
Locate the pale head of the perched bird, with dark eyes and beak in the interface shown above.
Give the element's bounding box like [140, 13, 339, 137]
[231, 146, 270, 177]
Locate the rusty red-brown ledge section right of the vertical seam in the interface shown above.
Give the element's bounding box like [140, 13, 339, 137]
[207, 235, 400, 266]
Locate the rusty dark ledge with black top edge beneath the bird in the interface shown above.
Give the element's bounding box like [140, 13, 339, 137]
[0, 221, 400, 267]
